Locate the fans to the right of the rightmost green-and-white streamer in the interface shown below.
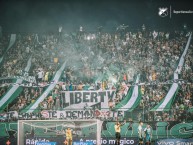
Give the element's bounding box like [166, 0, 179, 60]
[172, 43, 193, 121]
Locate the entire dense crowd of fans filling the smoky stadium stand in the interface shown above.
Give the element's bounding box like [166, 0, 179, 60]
[0, 26, 193, 121]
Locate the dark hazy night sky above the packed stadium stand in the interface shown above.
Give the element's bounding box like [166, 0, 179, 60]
[0, 0, 193, 32]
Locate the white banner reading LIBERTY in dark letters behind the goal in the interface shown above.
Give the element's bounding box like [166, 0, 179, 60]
[61, 90, 115, 109]
